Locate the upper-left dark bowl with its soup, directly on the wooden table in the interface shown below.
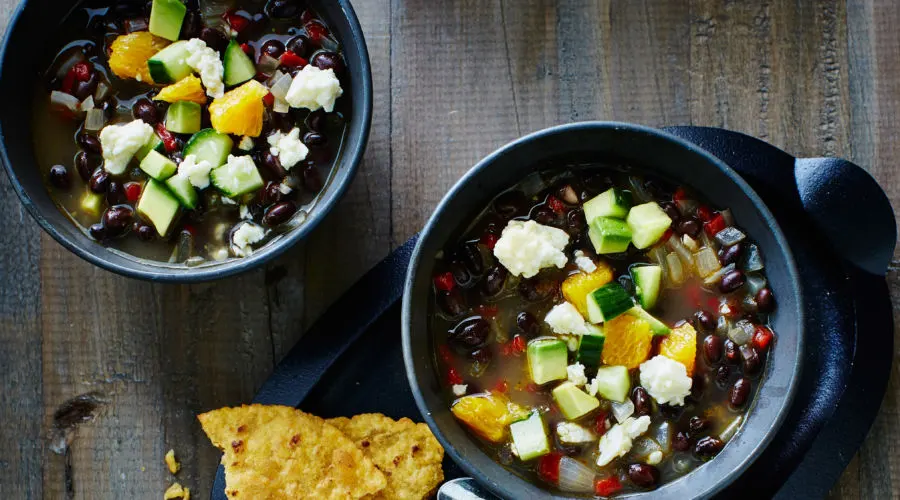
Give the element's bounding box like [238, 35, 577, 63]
[0, 0, 372, 282]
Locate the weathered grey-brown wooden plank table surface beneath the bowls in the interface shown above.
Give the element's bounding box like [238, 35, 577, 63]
[0, 0, 900, 499]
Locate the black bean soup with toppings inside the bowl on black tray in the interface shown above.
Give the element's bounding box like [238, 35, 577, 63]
[431, 164, 775, 496]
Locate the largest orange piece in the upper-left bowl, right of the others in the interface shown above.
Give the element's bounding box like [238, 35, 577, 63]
[209, 80, 269, 137]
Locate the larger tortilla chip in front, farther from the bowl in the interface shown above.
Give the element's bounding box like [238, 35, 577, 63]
[197, 405, 387, 500]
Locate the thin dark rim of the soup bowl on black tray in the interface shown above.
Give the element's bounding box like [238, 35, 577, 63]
[401, 121, 806, 498]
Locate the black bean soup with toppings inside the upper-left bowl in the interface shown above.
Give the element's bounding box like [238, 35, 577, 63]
[32, 0, 351, 266]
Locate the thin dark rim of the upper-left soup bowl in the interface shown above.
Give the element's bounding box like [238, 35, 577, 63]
[0, 0, 374, 283]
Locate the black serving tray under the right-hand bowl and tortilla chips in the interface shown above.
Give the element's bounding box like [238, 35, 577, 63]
[212, 127, 896, 500]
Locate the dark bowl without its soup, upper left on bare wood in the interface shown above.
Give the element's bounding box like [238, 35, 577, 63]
[0, 0, 372, 283]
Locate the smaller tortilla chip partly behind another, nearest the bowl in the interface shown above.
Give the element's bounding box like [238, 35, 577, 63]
[326, 413, 444, 500]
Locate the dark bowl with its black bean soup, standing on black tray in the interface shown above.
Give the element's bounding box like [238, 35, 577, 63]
[403, 122, 804, 498]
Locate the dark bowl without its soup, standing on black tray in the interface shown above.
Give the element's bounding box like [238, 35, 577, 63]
[402, 122, 804, 498]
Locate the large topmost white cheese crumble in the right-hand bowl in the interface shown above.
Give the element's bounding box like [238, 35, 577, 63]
[494, 220, 569, 278]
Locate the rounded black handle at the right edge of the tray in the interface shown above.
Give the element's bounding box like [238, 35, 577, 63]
[794, 158, 897, 276]
